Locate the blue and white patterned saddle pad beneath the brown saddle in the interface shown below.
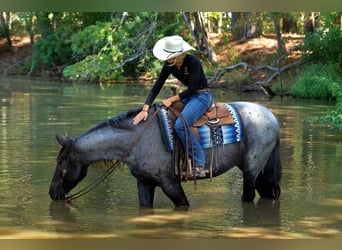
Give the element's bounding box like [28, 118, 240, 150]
[159, 104, 243, 151]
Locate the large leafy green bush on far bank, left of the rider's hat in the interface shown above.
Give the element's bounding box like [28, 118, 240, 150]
[63, 12, 190, 81]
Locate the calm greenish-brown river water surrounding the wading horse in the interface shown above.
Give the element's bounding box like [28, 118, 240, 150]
[0, 78, 342, 239]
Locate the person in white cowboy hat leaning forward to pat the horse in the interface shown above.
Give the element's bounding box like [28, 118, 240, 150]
[133, 35, 212, 176]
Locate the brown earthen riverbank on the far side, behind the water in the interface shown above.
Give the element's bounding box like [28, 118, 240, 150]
[0, 34, 303, 90]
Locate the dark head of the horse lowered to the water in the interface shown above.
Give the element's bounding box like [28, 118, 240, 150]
[49, 136, 88, 200]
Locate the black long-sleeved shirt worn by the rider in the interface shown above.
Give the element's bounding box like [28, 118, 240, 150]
[145, 54, 208, 105]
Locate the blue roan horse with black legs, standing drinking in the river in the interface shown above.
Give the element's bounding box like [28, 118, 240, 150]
[49, 102, 281, 207]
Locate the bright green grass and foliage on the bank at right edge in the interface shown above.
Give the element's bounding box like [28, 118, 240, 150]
[291, 12, 342, 129]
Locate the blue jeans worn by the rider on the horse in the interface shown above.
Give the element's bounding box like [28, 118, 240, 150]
[175, 92, 212, 167]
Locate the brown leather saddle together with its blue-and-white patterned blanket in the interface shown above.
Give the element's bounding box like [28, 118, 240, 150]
[159, 101, 243, 151]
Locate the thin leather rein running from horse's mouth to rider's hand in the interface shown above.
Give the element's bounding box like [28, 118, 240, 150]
[61, 106, 160, 202]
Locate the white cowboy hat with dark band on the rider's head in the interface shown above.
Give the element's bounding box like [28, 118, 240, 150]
[153, 36, 195, 61]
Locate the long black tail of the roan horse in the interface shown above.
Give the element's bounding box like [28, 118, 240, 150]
[255, 134, 282, 199]
